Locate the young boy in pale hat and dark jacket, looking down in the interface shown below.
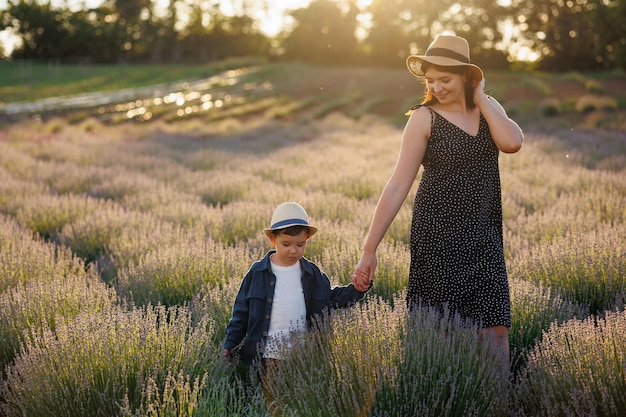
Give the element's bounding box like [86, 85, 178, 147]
[222, 202, 367, 365]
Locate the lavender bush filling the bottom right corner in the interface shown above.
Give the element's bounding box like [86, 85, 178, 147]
[514, 311, 626, 416]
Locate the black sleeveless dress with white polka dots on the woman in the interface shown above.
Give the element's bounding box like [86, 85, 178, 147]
[407, 107, 511, 327]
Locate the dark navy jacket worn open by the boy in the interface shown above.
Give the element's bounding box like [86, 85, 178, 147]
[223, 250, 365, 364]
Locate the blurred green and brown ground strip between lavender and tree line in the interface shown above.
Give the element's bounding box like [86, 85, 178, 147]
[0, 58, 626, 129]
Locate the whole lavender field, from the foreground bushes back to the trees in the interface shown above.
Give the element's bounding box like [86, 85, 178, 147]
[0, 60, 626, 416]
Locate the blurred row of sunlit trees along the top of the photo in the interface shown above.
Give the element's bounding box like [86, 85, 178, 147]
[0, 0, 626, 71]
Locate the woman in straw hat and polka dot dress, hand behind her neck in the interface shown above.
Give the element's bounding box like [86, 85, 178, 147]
[352, 35, 523, 359]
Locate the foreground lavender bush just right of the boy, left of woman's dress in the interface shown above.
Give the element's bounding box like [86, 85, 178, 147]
[266, 300, 394, 417]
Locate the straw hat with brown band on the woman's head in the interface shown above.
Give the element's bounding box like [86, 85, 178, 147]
[406, 35, 483, 81]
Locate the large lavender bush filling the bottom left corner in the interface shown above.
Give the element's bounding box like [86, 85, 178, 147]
[3, 307, 217, 417]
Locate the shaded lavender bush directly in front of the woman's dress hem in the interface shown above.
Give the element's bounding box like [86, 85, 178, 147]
[371, 302, 508, 416]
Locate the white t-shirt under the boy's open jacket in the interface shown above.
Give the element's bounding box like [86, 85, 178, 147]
[263, 262, 306, 359]
